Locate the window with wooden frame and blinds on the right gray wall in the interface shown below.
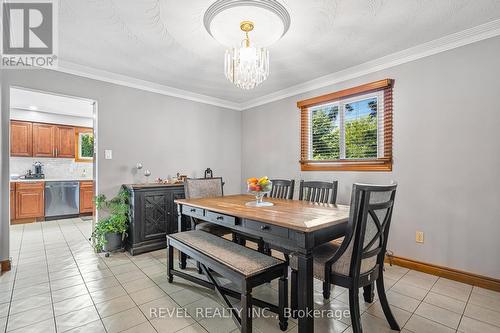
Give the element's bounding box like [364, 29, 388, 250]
[297, 79, 393, 171]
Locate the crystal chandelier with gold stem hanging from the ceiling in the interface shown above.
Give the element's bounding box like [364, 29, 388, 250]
[224, 21, 269, 90]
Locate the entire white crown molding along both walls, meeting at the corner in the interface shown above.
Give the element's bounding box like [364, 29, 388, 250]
[54, 19, 500, 111]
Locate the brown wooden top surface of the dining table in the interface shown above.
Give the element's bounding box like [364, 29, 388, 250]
[175, 194, 349, 232]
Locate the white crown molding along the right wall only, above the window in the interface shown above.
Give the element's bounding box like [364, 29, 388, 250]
[240, 19, 500, 110]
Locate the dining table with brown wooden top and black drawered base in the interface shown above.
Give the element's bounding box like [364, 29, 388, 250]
[175, 194, 349, 333]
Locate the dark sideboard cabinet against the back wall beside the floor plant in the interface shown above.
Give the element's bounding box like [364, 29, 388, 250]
[123, 184, 188, 255]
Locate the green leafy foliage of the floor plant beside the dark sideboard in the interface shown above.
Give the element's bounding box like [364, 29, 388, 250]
[92, 188, 129, 251]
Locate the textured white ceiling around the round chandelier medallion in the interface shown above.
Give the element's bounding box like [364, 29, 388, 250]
[59, 0, 500, 103]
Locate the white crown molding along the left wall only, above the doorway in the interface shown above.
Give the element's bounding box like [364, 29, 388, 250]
[53, 60, 241, 111]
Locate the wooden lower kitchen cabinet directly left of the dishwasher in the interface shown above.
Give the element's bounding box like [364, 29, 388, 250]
[15, 182, 45, 219]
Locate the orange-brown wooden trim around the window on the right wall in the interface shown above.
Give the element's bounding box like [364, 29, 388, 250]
[297, 79, 394, 172]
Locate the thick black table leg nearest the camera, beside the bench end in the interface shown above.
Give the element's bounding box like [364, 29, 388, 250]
[297, 253, 314, 333]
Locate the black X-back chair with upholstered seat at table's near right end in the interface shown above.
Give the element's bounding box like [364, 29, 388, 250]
[290, 184, 399, 333]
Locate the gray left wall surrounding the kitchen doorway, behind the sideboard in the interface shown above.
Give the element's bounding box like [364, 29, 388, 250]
[0, 70, 241, 259]
